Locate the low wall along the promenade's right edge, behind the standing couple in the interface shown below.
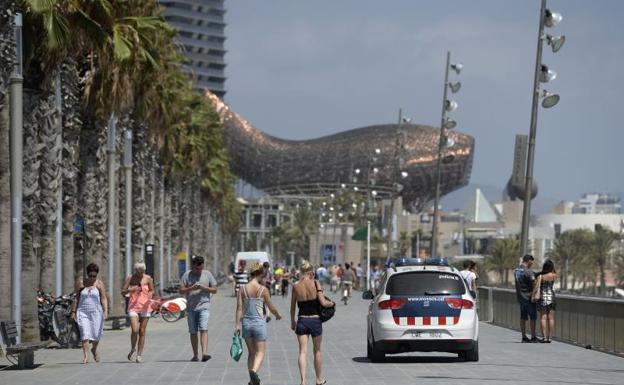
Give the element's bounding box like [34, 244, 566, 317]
[478, 287, 624, 353]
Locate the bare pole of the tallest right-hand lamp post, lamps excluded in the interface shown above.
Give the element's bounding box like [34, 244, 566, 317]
[519, 0, 546, 259]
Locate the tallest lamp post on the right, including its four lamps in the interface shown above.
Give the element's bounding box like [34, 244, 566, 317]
[520, 0, 565, 258]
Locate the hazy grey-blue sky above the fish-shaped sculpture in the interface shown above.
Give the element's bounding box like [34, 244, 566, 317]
[225, 0, 624, 199]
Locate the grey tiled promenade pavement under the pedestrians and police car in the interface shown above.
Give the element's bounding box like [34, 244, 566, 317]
[0, 284, 624, 385]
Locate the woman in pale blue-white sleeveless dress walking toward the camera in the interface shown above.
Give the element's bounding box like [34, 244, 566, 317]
[72, 263, 108, 364]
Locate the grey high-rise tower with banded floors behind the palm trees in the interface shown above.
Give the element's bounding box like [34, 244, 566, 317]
[160, 0, 226, 98]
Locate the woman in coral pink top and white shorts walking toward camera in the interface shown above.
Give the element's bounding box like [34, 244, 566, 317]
[121, 262, 154, 364]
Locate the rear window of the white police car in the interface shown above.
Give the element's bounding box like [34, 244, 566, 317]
[386, 271, 466, 296]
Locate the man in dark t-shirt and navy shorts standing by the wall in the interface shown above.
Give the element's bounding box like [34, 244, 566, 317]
[514, 254, 537, 342]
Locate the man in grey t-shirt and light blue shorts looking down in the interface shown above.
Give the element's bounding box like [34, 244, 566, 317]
[179, 256, 217, 362]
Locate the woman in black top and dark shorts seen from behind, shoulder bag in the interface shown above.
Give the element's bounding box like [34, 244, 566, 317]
[290, 261, 334, 385]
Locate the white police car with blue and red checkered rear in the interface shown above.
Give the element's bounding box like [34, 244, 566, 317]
[362, 258, 479, 362]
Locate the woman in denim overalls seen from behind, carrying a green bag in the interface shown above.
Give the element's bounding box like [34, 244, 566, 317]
[236, 262, 282, 385]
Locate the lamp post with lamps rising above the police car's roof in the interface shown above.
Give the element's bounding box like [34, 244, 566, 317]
[430, 52, 463, 257]
